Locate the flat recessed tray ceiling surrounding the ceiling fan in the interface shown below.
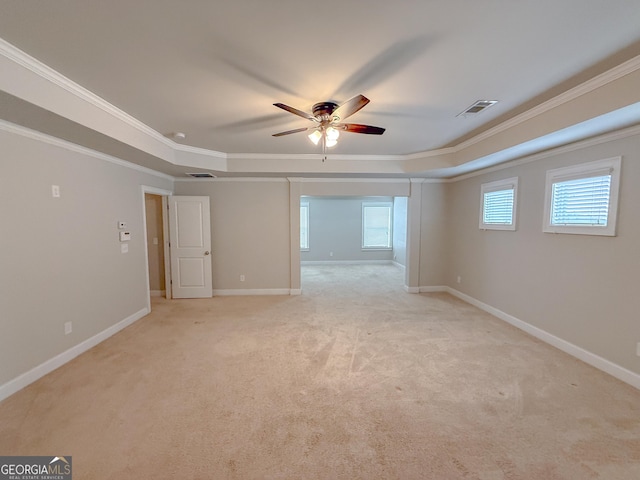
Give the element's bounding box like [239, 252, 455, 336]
[0, 0, 640, 176]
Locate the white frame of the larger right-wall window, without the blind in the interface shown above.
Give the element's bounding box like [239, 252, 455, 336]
[542, 157, 622, 237]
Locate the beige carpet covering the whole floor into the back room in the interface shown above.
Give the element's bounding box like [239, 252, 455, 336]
[0, 266, 640, 480]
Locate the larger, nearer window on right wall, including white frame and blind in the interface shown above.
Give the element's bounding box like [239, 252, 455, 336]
[543, 157, 621, 236]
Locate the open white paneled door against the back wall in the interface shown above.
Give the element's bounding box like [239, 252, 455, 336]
[169, 196, 213, 298]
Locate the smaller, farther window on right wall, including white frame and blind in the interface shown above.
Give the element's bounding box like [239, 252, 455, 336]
[480, 177, 518, 230]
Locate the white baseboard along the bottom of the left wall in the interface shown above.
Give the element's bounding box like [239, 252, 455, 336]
[0, 308, 149, 401]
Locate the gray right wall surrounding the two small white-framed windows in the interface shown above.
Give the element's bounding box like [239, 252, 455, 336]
[447, 135, 640, 373]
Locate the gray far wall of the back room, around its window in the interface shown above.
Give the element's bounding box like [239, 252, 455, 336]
[300, 197, 393, 262]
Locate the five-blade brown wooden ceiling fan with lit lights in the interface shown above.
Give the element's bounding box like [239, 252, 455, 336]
[273, 95, 385, 152]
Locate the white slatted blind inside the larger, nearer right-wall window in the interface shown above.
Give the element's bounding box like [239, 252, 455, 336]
[551, 175, 611, 227]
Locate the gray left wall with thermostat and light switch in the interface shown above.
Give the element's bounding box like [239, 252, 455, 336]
[0, 126, 172, 385]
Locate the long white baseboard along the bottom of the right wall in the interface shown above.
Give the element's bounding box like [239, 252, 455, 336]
[442, 287, 640, 390]
